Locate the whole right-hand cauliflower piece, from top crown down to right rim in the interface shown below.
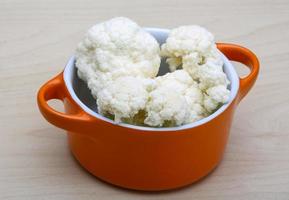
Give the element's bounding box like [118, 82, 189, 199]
[161, 26, 230, 113]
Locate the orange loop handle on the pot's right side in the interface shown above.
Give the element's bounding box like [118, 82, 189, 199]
[217, 43, 259, 101]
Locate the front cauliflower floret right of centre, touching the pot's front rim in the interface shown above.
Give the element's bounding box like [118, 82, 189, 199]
[144, 70, 204, 126]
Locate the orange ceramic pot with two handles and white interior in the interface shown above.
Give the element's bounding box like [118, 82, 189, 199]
[37, 28, 259, 191]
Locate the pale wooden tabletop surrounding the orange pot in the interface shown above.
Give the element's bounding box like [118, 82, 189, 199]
[0, 0, 289, 200]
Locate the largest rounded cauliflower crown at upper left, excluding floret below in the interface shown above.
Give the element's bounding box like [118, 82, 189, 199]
[75, 17, 160, 85]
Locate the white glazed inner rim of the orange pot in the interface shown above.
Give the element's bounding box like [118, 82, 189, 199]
[63, 28, 239, 131]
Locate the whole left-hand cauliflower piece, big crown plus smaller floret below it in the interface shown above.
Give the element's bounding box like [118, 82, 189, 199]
[75, 17, 160, 122]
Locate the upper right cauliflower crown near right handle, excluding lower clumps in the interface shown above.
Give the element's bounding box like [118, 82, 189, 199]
[161, 26, 226, 82]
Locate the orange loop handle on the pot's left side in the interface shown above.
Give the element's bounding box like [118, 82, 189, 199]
[37, 73, 90, 132]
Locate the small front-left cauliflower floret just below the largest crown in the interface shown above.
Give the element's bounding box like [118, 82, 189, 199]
[97, 76, 155, 122]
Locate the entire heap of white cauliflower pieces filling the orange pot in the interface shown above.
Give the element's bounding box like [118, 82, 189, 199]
[75, 17, 230, 127]
